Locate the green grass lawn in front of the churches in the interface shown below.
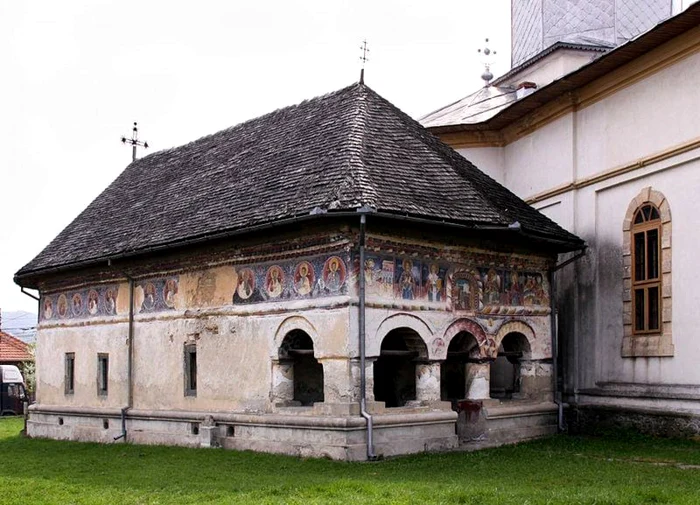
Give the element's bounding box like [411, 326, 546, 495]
[0, 418, 700, 505]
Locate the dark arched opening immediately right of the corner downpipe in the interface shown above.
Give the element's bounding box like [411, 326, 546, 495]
[374, 328, 428, 407]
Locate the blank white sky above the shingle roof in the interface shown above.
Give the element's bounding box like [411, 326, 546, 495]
[0, 0, 510, 312]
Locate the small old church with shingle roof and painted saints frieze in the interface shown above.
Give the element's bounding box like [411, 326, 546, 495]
[16, 78, 584, 460]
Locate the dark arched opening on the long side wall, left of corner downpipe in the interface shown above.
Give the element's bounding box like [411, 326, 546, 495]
[279, 330, 323, 406]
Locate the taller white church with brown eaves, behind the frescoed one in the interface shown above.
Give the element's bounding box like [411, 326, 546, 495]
[421, 0, 700, 435]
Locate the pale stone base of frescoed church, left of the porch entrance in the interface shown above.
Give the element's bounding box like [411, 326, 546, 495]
[28, 405, 458, 461]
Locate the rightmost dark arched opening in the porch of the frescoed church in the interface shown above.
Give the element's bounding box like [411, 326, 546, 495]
[489, 332, 530, 400]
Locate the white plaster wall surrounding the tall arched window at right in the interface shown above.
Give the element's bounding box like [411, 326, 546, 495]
[470, 46, 700, 398]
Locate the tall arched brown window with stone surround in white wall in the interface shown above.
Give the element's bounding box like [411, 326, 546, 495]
[622, 188, 673, 357]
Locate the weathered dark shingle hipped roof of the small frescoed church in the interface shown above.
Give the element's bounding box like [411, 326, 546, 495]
[15, 83, 583, 285]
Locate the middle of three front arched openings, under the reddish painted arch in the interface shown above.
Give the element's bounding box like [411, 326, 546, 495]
[440, 331, 479, 407]
